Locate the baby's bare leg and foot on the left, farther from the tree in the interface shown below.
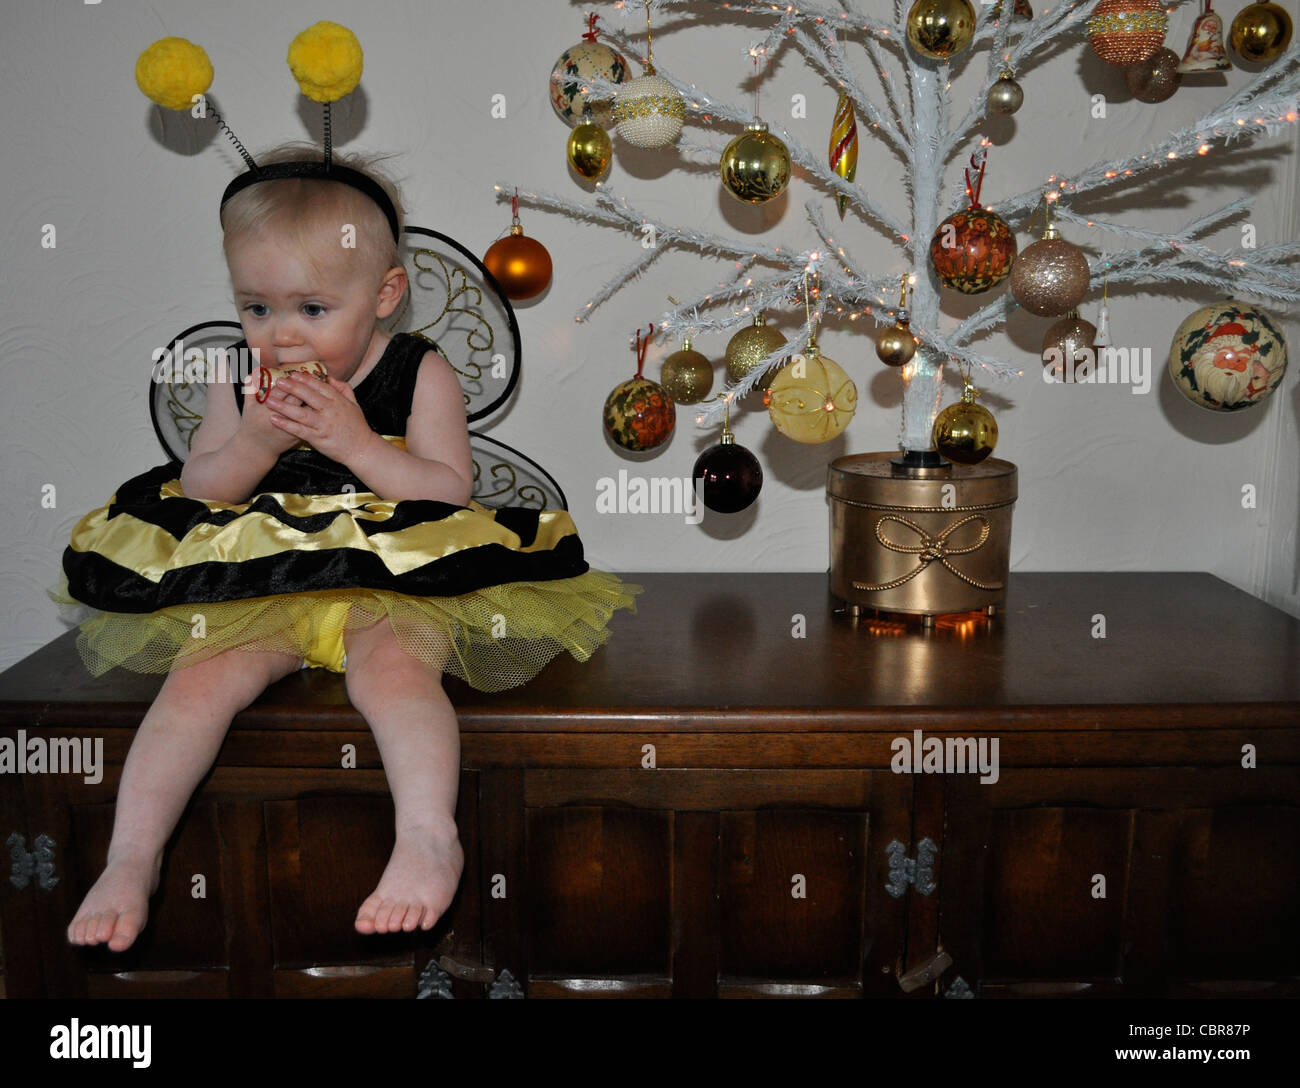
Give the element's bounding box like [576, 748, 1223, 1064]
[68, 651, 302, 952]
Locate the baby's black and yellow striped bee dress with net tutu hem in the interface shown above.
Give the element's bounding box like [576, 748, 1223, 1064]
[51, 333, 641, 692]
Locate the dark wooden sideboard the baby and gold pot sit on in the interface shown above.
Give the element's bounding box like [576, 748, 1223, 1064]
[0, 573, 1300, 1000]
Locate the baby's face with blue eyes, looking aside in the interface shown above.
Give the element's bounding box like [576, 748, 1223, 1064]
[226, 234, 380, 381]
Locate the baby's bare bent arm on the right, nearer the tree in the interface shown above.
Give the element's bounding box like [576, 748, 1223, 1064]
[347, 351, 475, 506]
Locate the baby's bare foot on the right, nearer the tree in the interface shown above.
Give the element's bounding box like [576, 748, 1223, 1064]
[354, 824, 465, 933]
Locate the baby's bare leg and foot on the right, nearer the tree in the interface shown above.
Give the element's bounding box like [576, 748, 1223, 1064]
[345, 620, 465, 933]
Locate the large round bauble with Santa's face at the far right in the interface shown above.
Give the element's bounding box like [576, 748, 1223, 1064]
[1169, 299, 1287, 412]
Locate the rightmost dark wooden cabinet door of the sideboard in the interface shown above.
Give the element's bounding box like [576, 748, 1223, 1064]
[939, 767, 1300, 997]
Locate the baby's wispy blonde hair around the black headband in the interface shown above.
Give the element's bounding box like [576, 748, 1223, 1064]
[221, 143, 406, 283]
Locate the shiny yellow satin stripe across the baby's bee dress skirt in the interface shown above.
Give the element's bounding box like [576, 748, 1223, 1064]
[69, 435, 577, 582]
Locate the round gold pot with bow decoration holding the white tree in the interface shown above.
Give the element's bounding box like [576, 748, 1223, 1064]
[826, 452, 1017, 624]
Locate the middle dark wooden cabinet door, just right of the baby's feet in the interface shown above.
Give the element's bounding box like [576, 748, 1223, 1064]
[480, 770, 910, 997]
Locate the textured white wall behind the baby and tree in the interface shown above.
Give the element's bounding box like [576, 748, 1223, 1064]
[0, 0, 1300, 666]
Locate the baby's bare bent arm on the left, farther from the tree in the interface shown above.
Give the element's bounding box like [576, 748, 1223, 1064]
[181, 363, 298, 503]
